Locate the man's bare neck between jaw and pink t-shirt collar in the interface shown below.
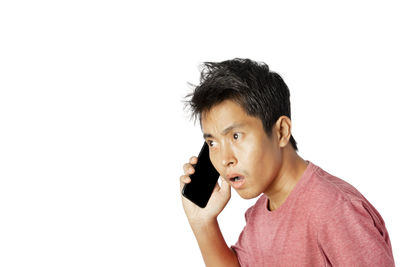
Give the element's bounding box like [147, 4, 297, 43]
[264, 147, 307, 211]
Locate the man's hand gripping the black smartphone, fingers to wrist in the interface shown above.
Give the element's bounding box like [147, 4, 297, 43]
[180, 157, 231, 228]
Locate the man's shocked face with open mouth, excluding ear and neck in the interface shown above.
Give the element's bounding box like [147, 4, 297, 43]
[202, 100, 282, 199]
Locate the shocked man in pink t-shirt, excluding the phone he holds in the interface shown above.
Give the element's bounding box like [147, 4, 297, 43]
[180, 59, 394, 267]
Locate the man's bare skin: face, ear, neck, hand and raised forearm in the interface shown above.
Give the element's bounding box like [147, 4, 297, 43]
[180, 100, 307, 266]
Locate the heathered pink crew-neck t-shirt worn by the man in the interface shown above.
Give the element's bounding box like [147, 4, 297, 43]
[232, 162, 394, 267]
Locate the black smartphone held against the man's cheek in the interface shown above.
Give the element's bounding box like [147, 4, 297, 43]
[182, 142, 219, 208]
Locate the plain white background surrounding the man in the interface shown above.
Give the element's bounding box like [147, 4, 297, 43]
[0, 0, 400, 266]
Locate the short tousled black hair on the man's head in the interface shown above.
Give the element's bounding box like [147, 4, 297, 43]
[186, 58, 298, 151]
